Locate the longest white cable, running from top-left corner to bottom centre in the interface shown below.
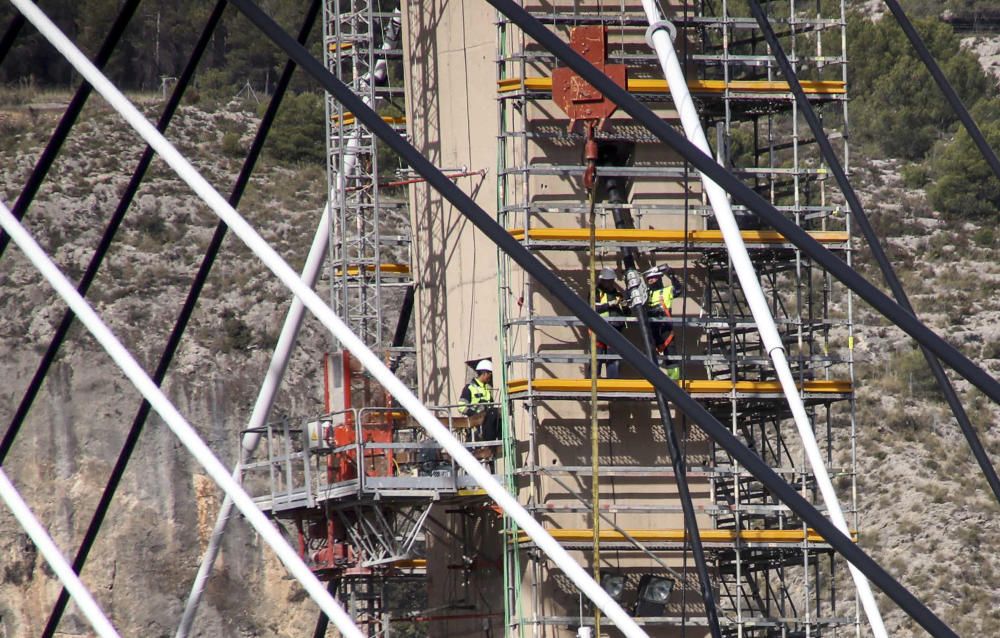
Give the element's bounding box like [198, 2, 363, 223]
[11, 0, 648, 638]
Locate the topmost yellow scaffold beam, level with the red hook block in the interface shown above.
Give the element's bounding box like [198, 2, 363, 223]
[497, 77, 847, 95]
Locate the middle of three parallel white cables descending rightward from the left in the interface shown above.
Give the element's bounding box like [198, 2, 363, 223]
[0, 196, 362, 638]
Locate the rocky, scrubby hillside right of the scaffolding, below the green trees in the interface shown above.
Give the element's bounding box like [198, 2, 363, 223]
[828, 160, 1000, 636]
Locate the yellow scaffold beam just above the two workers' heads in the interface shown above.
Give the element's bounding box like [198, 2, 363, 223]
[510, 228, 850, 244]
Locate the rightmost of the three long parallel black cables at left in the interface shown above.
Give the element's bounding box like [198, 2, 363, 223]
[43, 0, 321, 638]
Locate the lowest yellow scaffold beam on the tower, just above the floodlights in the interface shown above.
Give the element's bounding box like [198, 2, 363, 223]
[517, 529, 857, 543]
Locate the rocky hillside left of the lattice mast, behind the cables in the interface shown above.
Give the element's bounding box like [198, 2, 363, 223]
[0, 96, 336, 636]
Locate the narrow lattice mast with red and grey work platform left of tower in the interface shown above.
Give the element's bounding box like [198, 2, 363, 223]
[243, 0, 426, 635]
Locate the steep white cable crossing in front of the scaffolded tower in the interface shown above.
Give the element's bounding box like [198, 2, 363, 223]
[642, 0, 888, 638]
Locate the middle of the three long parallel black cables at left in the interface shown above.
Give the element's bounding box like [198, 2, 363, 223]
[0, 0, 226, 466]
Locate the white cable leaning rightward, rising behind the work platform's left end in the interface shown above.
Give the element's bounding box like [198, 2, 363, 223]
[176, 202, 330, 638]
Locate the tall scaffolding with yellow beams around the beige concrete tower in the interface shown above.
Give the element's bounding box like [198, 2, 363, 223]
[496, 0, 860, 636]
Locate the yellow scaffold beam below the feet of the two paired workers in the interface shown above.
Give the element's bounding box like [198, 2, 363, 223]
[507, 379, 851, 394]
